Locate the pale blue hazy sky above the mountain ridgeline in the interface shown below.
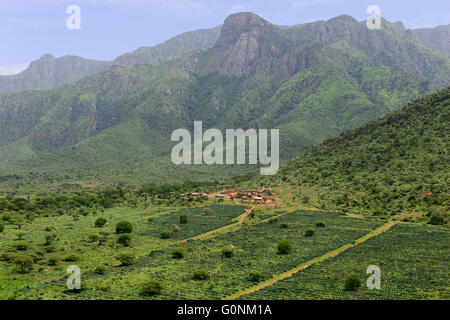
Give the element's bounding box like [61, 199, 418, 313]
[0, 0, 450, 74]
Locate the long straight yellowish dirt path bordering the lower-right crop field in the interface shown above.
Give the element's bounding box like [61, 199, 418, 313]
[224, 221, 396, 300]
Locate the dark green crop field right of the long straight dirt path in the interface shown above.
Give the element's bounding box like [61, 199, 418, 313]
[241, 223, 450, 299]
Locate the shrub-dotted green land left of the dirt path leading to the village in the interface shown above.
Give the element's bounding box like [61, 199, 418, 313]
[0, 205, 246, 299]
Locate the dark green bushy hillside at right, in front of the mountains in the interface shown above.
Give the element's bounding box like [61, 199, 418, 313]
[276, 88, 450, 220]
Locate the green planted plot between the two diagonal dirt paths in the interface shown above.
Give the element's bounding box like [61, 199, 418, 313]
[27, 211, 382, 299]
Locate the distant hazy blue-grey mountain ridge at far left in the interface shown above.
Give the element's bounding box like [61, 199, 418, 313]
[0, 54, 111, 94]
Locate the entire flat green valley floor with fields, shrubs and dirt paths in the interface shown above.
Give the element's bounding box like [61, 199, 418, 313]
[0, 199, 450, 299]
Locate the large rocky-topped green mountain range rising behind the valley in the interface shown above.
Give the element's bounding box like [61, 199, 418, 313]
[0, 13, 450, 190]
